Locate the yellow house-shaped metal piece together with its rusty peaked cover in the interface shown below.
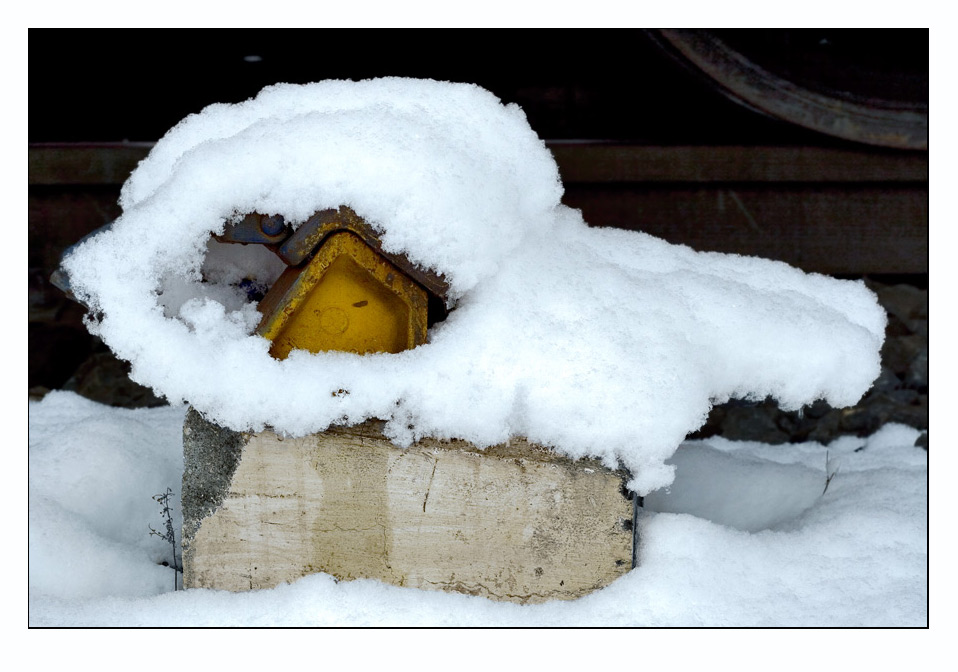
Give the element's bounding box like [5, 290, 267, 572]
[249, 206, 449, 359]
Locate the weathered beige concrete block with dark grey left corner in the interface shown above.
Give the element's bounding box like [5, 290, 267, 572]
[183, 411, 634, 603]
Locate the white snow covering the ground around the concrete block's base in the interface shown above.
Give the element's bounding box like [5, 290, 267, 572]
[29, 392, 928, 627]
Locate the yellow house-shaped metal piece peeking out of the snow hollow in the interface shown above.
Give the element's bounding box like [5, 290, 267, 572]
[257, 231, 428, 359]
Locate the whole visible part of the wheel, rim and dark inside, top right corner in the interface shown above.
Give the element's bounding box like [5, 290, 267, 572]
[651, 29, 928, 150]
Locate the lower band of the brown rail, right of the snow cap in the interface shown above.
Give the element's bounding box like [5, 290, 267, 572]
[563, 185, 928, 274]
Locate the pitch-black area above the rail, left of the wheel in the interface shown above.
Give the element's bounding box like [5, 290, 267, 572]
[28, 29, 833, 144]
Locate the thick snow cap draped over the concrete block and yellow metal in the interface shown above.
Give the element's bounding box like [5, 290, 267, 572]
[65, 79, 885, 494]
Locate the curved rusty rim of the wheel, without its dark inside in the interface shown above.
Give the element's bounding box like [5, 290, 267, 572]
[656, 30, 928, 150]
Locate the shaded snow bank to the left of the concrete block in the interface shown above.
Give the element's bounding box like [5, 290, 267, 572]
[29, 391, 185, 598]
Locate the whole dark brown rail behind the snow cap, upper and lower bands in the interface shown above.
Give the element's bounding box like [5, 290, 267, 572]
[29, 142, 928, 274]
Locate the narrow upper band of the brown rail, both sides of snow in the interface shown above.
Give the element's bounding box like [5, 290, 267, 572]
[29, 141, 928, 185]
